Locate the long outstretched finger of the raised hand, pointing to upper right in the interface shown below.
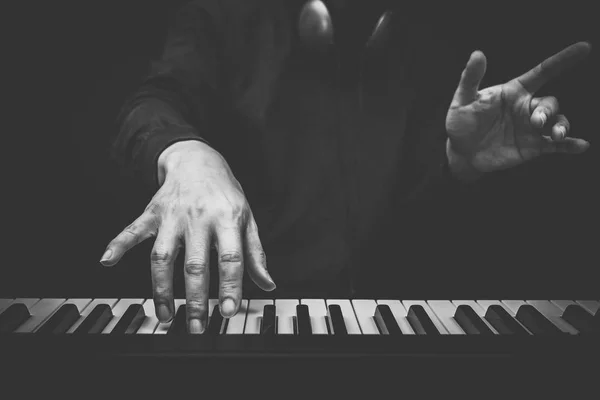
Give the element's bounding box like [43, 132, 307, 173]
[516, 42, 591, 93]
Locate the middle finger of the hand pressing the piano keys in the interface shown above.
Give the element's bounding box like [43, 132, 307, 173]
[183, 222, 211, 333]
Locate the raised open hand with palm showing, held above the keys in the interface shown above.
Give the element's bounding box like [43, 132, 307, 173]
[446, 42, 590, 177]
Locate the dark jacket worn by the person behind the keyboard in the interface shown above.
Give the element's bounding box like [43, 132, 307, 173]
[113, 0, 466, 296]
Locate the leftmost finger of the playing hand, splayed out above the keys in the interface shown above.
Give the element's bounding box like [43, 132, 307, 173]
[100, 210, 156, 267]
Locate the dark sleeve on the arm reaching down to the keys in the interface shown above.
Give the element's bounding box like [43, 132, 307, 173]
[112, 0, 222, 188]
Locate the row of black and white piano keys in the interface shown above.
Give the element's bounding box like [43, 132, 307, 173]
[0, 298, 600, 337]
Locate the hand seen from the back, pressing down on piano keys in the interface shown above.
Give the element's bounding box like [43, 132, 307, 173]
[101, 141, 275, 333]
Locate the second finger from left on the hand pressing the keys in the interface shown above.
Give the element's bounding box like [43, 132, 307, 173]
[150, 219, 180, 323]
